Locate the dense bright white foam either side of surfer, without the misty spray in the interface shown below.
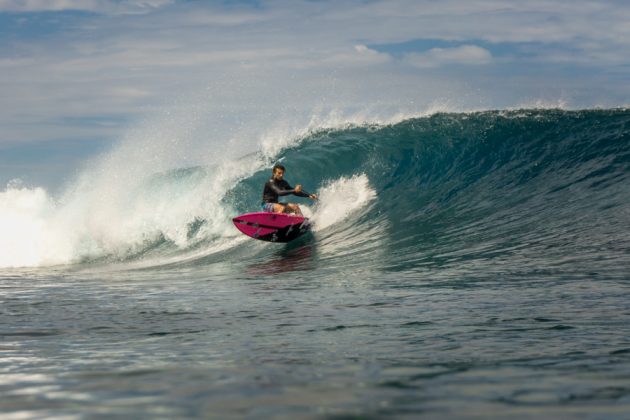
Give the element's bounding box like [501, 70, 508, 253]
[0, 175, 375, 267]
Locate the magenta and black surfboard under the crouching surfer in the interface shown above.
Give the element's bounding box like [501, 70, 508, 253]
[232, 212, 311, 242]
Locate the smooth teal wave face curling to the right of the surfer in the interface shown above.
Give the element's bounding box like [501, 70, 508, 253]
[256, 110, 630, 276]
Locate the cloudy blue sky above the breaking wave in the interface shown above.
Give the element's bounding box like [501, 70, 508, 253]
[0, 0, 630, 185]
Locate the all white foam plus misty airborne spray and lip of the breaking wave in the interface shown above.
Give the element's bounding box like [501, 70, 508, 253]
[0, 101, 399, 267]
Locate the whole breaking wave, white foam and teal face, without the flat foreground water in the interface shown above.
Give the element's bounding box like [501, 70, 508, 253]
[0, 110, 630, 276]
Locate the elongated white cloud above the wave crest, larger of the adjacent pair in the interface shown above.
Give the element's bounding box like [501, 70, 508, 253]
[404, 45, 492, 68]
